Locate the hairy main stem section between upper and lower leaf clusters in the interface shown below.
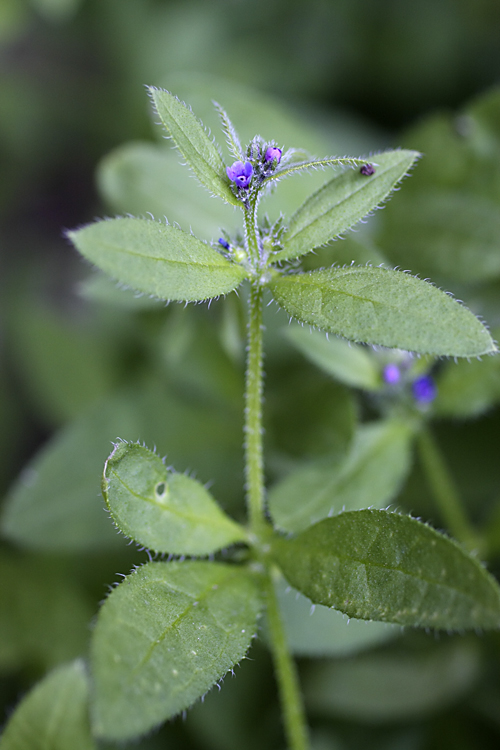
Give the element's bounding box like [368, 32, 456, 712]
[245, 281, 265, 534]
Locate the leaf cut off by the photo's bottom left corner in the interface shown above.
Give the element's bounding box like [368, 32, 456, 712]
[0, 661, 96, 750]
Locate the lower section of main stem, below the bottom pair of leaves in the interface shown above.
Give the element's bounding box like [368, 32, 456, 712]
[267, 572, 309, 750]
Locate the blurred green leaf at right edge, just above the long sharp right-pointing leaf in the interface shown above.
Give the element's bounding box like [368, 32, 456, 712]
[379, 192, 500, 282]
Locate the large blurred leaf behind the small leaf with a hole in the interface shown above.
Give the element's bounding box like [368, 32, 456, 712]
[2, 381, 243, 552]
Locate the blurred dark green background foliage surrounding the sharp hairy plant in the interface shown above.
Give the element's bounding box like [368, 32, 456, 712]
[0, 0, 500, 750]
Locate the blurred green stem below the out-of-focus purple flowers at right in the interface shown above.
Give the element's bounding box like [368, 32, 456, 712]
[417, 427, 479, 550]
